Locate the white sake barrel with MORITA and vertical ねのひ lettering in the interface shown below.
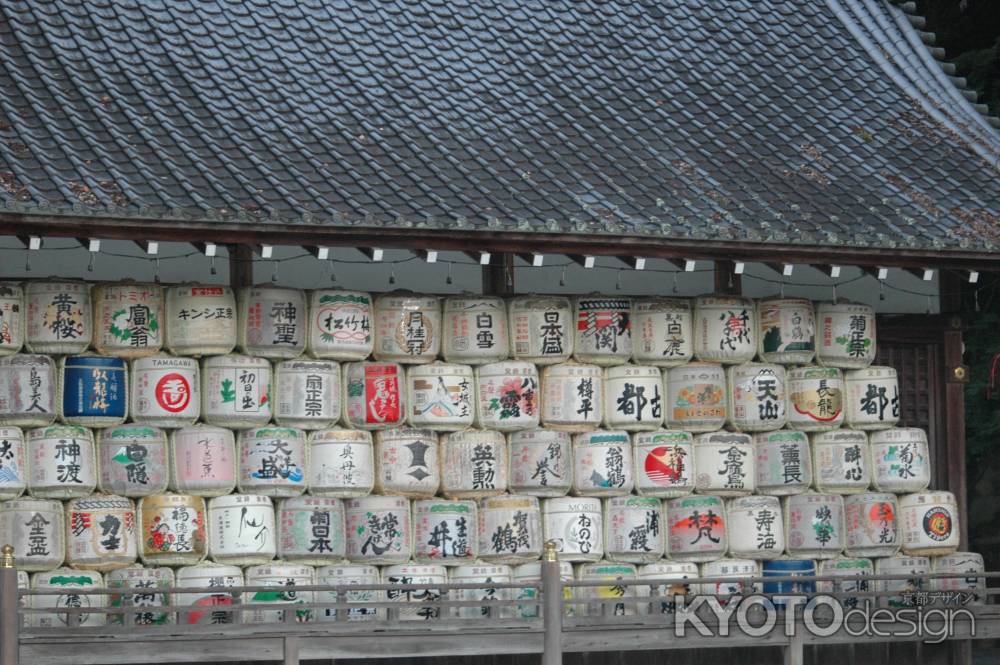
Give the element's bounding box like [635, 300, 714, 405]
[542, 496, 604, 562]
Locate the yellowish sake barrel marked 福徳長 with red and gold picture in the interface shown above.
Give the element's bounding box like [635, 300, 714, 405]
[138, 494, 208, 566]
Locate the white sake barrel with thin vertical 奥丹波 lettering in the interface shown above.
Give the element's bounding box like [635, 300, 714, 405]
[308, 429, 375, 499]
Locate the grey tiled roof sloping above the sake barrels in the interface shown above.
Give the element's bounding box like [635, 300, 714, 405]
[0, 0, 1000, 251]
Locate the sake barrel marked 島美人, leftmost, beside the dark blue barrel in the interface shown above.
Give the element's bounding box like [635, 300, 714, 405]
[0, 353, 58, 427]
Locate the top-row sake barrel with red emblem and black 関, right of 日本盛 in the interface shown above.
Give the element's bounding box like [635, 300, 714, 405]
[573, 294, 632, 366]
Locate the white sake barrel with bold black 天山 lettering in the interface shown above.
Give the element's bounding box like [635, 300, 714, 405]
[726, 363, 788, 432]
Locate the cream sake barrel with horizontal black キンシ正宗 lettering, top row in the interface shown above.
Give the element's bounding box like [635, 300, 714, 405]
[164, 284, 237, 356]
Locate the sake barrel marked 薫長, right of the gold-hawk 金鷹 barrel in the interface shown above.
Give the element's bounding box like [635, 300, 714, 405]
[754, 430, 813, 496]
